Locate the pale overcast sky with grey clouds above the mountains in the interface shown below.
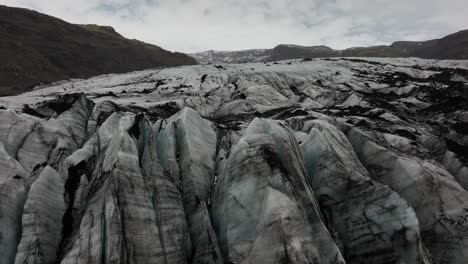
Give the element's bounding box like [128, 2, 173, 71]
[0, 0, 468, 53]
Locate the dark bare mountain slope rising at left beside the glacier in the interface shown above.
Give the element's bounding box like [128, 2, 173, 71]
[0, 6, 196, 95]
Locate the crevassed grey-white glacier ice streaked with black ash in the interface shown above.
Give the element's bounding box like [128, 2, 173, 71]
[0, 56, 468, 264]
